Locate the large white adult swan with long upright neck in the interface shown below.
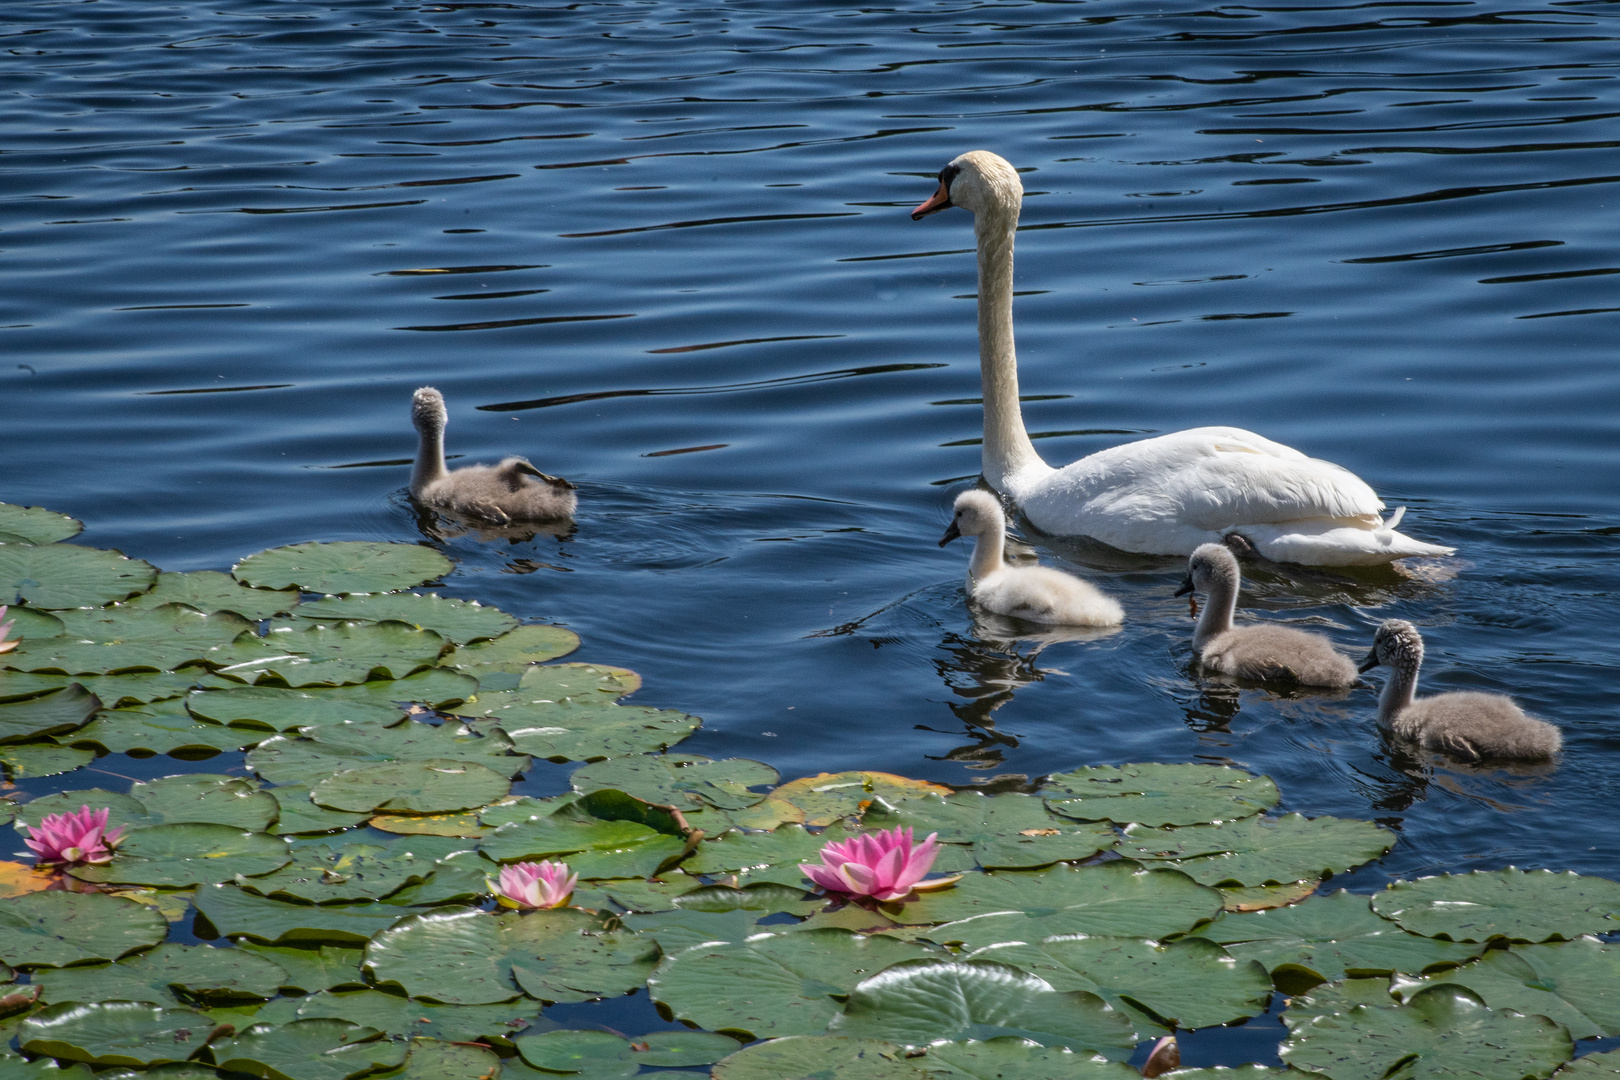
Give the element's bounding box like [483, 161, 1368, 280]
[912, 151, 1453, 567]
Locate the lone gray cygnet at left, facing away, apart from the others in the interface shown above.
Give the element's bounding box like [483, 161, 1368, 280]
[410, 387, 577, 525]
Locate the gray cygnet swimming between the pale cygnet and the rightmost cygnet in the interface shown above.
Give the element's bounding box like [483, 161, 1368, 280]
[1176, 544, 1356, 688]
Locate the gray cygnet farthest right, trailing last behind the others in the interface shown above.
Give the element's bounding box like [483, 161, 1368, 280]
[1361, 619, 1563, 761]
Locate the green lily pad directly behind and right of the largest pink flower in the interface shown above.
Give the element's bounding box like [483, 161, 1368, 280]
[860, 792, 1118, 868]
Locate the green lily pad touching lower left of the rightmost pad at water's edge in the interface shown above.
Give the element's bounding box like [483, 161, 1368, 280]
[1197, 891, 1479, 983]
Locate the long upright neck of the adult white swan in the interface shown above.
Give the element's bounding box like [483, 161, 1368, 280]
[974, 202, 1050, 494]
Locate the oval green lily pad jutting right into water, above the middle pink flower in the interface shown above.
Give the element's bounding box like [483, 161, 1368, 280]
[466, 703, 703, 761]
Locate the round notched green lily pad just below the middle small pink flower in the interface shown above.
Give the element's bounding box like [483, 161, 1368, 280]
[366, 908, 658, 1006]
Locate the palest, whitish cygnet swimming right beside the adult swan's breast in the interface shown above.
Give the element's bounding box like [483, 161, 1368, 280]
[940, 491, 1124, 627]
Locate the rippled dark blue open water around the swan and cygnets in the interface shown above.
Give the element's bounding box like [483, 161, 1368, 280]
[9, 0, 1620, 1064]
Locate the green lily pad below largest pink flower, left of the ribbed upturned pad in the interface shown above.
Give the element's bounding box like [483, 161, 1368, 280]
[648, 929, 940, 1038]
